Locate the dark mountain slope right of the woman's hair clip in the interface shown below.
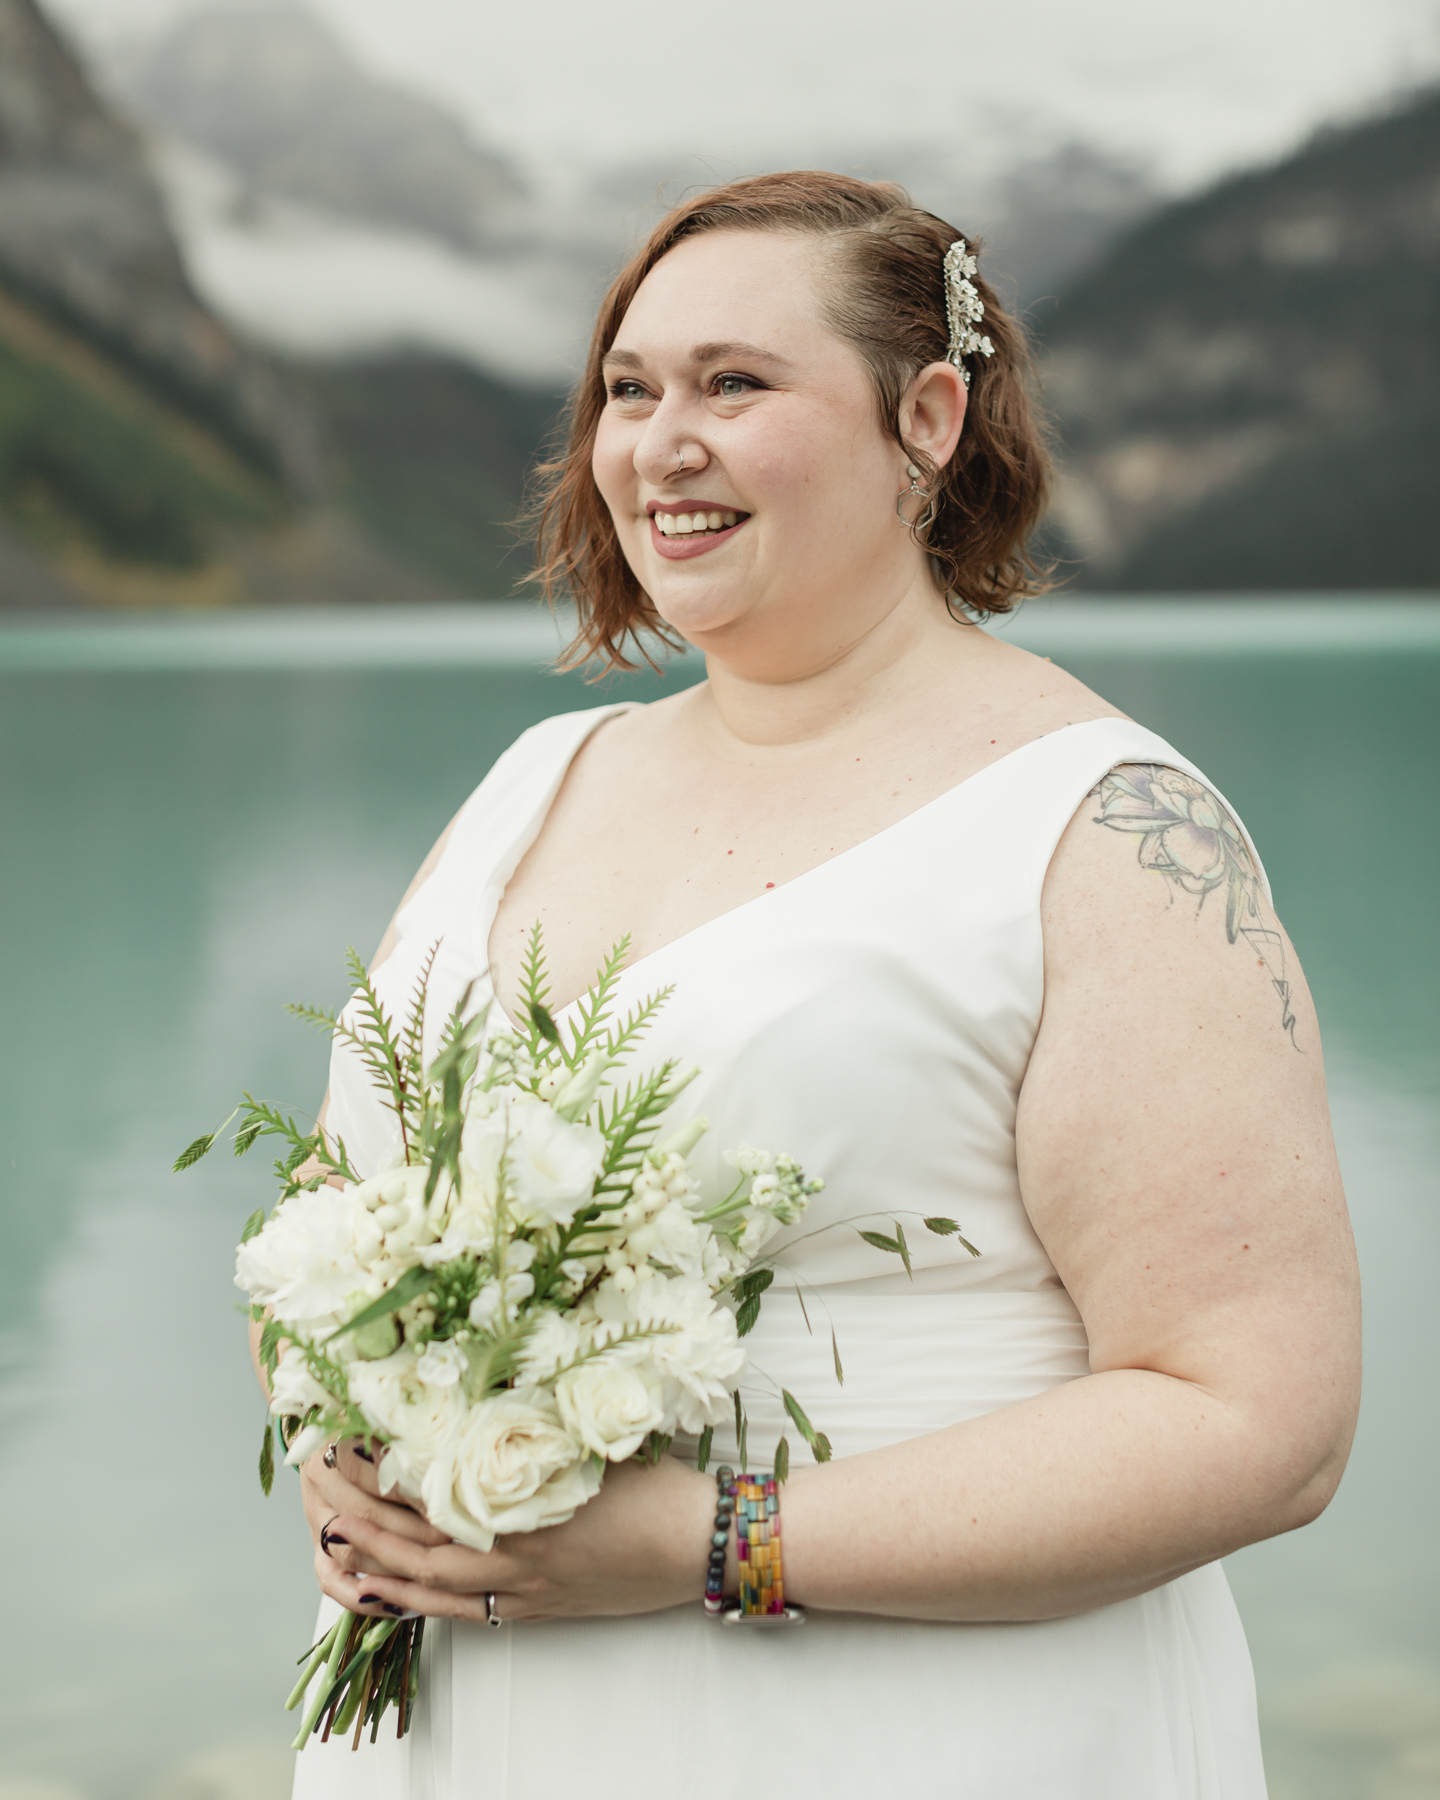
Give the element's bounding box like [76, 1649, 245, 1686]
[1037, 94, 1440, 590]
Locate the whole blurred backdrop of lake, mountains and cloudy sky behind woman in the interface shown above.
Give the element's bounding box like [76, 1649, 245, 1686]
[0, 0, 1440, 1800]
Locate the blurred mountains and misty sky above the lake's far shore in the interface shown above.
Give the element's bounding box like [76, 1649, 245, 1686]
[0, 0, 1440, 608]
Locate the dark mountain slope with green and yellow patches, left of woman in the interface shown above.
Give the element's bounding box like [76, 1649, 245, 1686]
[0, 0, 558, 607]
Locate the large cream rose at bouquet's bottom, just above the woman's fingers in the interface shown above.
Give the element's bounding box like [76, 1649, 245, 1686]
[421, 1388, 603, 1550]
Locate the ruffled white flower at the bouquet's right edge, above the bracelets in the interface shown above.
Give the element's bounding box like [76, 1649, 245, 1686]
[596, 1274, 745, 1431]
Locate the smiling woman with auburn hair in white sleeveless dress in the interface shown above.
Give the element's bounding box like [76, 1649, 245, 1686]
[275, 173, 1359, 1800]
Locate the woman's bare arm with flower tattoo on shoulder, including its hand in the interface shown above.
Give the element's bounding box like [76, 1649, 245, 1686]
[309, 770, 1359, 1620]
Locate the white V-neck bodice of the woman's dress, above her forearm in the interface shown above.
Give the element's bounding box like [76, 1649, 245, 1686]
[331, 707, 1260, 1453]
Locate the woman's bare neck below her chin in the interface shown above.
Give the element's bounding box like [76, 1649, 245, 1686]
[697, 580, 988, 749]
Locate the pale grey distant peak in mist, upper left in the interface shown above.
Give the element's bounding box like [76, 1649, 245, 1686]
[110, 4, 524, 252]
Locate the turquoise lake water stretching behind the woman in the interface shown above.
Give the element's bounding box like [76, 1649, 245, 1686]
[0, 596, 1440, 1800]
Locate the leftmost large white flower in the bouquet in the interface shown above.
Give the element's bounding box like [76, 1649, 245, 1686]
[236, 1186, 380, 1328]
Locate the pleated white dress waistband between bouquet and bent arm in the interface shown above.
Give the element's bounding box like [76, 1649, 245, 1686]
[675, 1274, 1089, 1467]
